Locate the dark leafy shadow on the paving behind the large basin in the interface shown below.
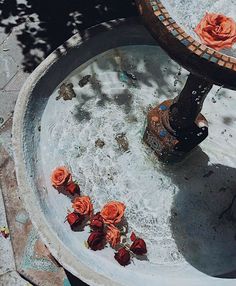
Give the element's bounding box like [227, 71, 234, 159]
[0, 0, 137, 72]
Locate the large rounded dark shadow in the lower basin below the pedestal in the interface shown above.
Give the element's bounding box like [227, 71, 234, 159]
[165, 148, 236, 278]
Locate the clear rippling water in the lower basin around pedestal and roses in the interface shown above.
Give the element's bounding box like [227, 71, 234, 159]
[36, 45, 236, 285]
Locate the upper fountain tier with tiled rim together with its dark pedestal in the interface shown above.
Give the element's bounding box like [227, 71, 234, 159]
[135, 0, 236, 162]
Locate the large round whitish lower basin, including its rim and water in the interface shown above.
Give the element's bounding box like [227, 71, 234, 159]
[13, 21, 236, 286]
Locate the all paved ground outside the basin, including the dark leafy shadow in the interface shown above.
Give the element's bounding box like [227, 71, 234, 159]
[0, 0, 136, 286]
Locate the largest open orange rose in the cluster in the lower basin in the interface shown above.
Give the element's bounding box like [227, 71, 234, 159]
[100, 202, 125, 224]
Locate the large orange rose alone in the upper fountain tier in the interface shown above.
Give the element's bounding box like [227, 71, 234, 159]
[194, 13, 236, 50]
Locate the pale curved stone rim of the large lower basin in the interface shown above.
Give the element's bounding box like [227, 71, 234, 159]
[12, 18, 156, 286]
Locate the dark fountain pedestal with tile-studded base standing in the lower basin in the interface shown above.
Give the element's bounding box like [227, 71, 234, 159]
[144, 74, 212, 163]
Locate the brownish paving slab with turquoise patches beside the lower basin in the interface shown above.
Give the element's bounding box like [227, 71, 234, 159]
[0, 146, 65, 286]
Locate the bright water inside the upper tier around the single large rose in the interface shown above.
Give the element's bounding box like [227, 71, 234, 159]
[161, 0, 236, 58]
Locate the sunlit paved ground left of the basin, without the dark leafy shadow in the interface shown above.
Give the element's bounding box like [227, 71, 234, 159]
[0, 20, 81, 286]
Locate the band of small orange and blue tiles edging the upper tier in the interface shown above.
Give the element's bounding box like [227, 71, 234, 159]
[146, 0, 236, 70]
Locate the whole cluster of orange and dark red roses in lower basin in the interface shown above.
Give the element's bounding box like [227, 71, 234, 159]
[51, 167, 147, 266]
